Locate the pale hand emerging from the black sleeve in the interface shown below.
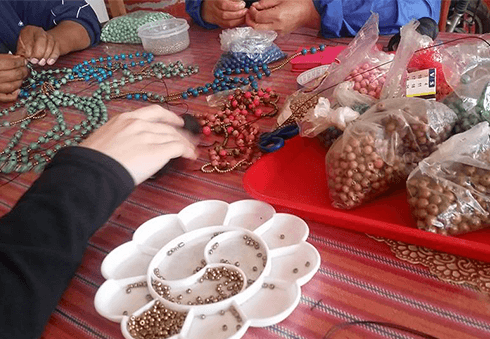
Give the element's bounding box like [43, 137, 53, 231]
[80, 105, 197, 185]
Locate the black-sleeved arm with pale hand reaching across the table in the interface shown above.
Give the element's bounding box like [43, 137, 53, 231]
[0, 106, 199, 339]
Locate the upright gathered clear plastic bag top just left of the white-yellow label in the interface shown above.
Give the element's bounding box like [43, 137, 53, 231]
[380, 20, 432, 99]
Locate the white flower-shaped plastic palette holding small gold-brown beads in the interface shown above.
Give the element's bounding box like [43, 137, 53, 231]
[94, 200, 321, 339]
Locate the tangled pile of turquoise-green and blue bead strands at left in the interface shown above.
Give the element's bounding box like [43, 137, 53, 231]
[0, 53, 189, 173]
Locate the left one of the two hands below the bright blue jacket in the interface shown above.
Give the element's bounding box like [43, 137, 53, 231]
[201, 0, 248, 28]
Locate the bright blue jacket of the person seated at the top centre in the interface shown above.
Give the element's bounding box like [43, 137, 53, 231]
[185, 0, 441, 38]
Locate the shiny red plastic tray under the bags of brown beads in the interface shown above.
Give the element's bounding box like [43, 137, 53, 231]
[243, 137, 490, 262]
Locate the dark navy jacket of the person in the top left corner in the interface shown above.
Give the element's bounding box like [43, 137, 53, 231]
[0, 0, 100, 53]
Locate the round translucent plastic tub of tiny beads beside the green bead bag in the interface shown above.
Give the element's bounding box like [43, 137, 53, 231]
[138, 18, 189, 55]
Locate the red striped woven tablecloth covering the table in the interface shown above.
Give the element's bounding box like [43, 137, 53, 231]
[0, 25, 490, 339]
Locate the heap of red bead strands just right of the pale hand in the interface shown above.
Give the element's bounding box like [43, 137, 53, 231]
[196, 88, 279, 173]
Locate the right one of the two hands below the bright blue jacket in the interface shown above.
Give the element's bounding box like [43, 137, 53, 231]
[245, 0, 320, 34]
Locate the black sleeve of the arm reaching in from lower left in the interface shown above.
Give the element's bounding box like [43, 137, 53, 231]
[0, 147, 134, 339]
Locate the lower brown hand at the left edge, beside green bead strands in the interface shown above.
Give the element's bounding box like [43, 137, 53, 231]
[0, 54, 29, 102]
